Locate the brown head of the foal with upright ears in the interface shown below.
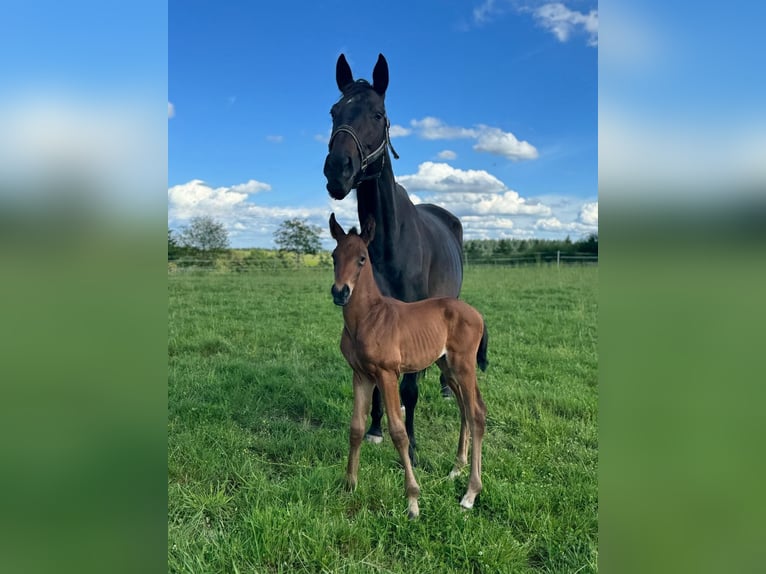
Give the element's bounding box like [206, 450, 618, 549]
[330, 213, 375, 307]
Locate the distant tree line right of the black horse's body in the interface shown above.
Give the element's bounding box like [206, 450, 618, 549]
[463, 233, 598, 263]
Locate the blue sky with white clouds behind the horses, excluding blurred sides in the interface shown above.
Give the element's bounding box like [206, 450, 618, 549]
[168, 0, 598, 247]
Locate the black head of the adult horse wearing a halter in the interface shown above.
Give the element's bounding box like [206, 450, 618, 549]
[324, 54, 397, 199]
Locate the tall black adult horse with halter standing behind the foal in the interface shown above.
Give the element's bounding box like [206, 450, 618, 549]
[324, 54, 463, 463]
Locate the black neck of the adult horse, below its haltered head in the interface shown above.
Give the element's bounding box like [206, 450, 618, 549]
[356, 156, 414, 260]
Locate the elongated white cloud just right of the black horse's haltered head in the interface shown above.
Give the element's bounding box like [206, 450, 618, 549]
[410, 116, 538, 161]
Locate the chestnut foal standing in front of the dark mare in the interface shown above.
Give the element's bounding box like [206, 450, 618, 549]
[330, 213, 487, 518]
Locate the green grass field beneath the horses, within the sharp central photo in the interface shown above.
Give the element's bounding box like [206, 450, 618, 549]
[168, 266, 598, 573]
